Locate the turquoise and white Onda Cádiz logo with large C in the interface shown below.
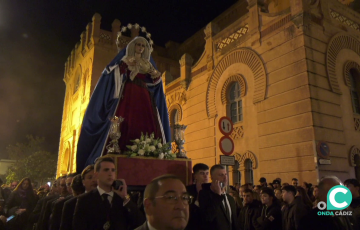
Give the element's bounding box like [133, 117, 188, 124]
[317, 185, 352, 216]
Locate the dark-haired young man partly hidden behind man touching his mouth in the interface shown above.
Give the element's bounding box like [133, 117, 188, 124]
[186, 163, 209, 230]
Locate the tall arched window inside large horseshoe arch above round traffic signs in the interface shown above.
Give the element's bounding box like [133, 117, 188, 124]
[228, 82, 243, 123]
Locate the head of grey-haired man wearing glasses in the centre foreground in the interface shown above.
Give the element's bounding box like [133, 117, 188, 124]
[144, 175, 191, 230]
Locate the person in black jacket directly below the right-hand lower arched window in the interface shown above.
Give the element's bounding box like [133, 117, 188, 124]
[238, 189, 261, 230]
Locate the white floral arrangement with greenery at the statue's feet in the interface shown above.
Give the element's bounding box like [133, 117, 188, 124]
[126, 133, 176, 159]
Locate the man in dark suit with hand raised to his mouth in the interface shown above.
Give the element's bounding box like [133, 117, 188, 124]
[199, 165, 238, 230]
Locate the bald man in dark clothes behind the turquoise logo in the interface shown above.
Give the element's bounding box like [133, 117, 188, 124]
[299, 176, 358, 230]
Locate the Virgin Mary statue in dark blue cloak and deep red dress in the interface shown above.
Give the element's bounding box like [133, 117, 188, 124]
[76, 37, 170, 172]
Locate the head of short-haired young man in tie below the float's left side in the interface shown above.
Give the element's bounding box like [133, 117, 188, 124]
[95, 157, 115, 188]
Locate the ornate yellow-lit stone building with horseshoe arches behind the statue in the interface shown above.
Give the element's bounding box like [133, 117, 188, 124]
[57, 0, 360, 183]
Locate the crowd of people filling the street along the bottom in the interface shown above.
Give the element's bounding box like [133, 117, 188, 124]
[0, 157, 360, 230]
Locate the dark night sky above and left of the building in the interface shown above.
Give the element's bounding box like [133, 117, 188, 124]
[0, 0, 237, 158]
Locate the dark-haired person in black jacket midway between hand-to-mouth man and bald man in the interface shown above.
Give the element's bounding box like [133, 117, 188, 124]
[257, 188, 282, 230]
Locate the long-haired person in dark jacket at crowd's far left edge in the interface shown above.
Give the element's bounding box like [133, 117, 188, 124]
[5, 178, 37, 229]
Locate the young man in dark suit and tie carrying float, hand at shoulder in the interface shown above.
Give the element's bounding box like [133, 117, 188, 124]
[73, 157, 145, 230]
